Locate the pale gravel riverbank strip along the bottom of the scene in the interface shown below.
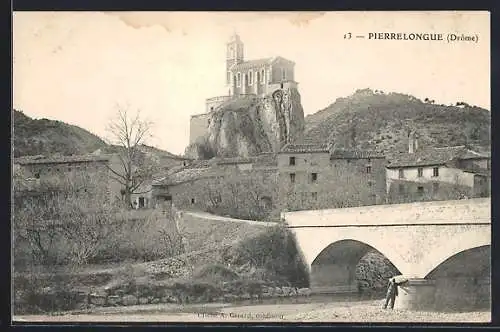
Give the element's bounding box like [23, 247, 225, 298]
[13, 300, 491, 323]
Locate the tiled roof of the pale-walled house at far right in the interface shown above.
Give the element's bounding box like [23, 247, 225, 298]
[387, 145, 489, 168]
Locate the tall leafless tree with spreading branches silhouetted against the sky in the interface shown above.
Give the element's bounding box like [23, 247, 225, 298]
[107, 108, 158, 207]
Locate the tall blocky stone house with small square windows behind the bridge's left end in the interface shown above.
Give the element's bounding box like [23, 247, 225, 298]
[278, 144, 386, 211]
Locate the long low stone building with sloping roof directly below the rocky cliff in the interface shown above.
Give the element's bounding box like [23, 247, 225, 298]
[152, 154, 279, 218]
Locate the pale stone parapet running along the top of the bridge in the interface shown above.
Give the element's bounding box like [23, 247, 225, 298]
[282, 198, 491, 228]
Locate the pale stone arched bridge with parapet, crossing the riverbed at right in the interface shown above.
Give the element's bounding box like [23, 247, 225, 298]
[282, 198, 491, 310]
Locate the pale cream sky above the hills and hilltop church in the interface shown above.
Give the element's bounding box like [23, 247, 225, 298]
[13, 12, 490, 154]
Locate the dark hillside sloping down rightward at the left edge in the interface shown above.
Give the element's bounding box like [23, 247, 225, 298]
[13, 110, 106, 157]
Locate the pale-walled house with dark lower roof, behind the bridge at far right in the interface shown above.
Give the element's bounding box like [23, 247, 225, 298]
[387, 144, 491, 203]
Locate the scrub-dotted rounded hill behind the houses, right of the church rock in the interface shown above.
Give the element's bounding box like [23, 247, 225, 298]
[304, 89, 491, 153]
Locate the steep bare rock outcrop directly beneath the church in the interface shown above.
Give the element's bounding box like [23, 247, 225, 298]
[186, 88, 304, 158]
